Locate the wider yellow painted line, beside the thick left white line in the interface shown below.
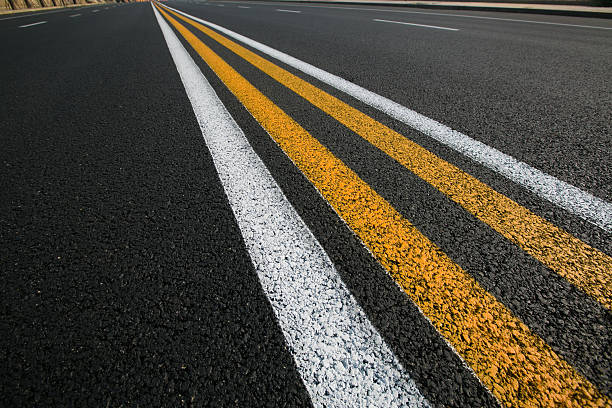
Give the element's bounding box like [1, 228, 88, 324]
[158, 3, 612, 407]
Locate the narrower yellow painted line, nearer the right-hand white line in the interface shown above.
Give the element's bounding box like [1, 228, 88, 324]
[160, 3, 612, 310]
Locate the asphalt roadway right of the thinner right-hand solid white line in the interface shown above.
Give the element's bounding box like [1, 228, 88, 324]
[182, 3, 611, 207]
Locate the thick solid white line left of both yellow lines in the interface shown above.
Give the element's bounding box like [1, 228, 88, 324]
[154, 3, 429, 407]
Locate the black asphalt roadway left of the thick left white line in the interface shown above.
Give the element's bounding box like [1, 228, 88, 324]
[0, 4, 309, 406]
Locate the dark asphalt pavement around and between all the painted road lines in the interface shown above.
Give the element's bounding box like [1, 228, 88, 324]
[0, 1, 612, 407]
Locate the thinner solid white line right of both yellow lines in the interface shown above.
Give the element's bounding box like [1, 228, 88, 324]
[161, 3, 612, 232]
